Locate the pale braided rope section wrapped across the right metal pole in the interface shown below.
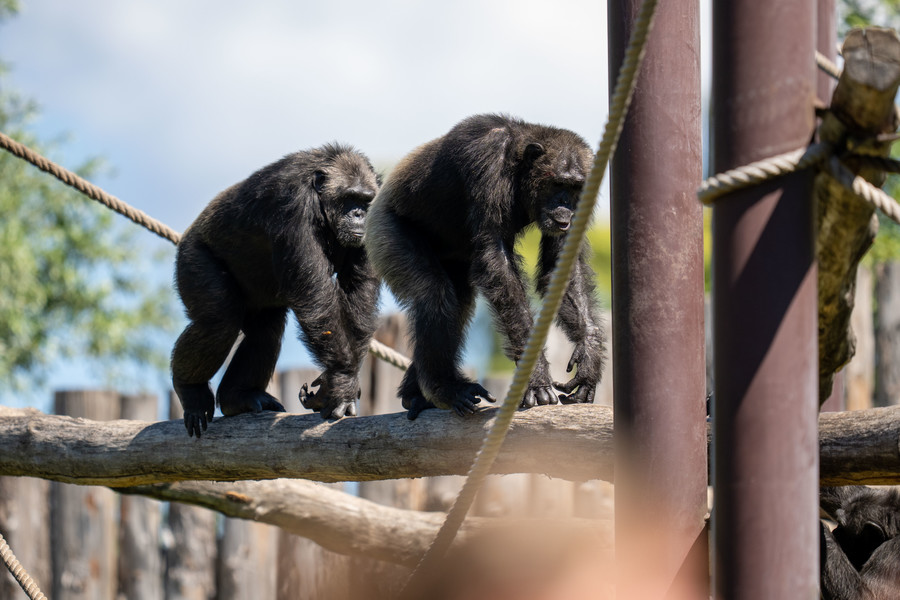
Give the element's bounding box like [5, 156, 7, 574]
[697, 144, 831, 205]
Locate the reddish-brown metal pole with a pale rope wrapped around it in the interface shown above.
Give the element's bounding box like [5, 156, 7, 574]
[713, 0, 819, 600]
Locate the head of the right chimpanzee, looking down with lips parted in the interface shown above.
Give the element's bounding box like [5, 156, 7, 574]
[520, 128, 592, 235]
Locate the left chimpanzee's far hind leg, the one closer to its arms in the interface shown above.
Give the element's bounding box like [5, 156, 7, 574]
[216, 308, 287, 416]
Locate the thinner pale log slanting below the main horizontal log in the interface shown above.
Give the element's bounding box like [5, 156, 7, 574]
[116, 479, 612, 567]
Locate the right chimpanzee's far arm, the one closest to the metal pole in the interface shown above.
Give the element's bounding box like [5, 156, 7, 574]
[537, 235, 606, 404]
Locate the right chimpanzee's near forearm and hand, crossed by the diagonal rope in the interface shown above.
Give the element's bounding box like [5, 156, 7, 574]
[472, 237, 557, 406]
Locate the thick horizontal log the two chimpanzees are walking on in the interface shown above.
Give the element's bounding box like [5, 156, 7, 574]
[0, 405, 900, 487]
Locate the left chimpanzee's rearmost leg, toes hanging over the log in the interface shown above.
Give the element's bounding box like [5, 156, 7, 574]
[172, 235, 244, 437]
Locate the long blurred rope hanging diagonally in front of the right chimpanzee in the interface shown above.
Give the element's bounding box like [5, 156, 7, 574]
[400, 0, 658, 597]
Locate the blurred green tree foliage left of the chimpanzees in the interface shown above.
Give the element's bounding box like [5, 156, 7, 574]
[0, 0, 175, 391]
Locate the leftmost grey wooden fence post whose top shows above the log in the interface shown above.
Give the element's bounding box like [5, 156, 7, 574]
[48, 391, 119, 600]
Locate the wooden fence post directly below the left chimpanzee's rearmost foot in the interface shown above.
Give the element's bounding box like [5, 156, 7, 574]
[165, 392, 217, 600]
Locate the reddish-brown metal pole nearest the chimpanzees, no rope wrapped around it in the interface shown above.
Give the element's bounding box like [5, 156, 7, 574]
[608, 0, 709, 598]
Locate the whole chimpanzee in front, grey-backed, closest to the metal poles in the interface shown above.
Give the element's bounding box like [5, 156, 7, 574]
[366, 115, 605, 419]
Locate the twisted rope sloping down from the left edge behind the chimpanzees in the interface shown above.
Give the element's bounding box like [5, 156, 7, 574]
[0, 131, 410, 370]
